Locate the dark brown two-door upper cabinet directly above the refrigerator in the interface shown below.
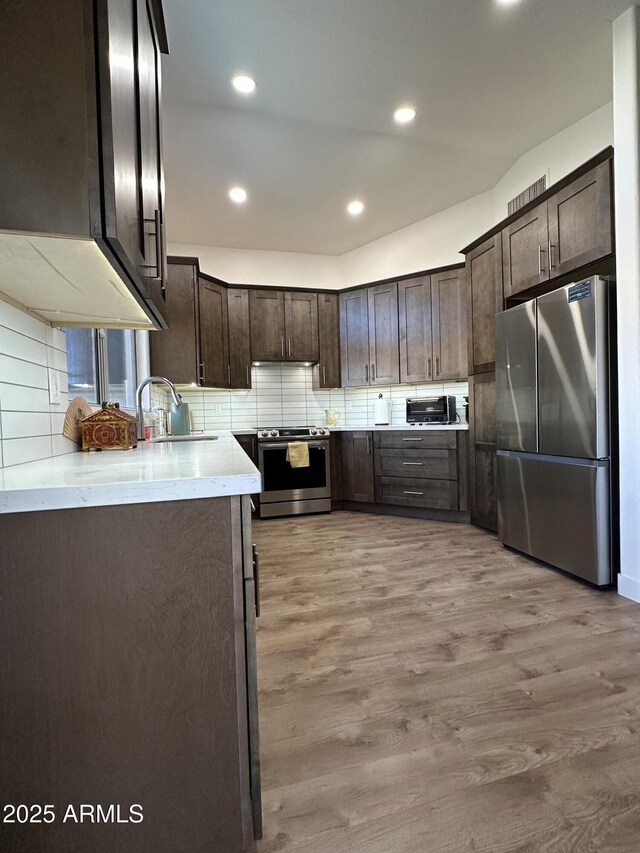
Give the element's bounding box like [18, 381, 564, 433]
[502, 160, 613, 297]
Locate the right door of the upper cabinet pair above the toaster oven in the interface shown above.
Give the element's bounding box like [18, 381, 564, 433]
[432, 270, 468, 381]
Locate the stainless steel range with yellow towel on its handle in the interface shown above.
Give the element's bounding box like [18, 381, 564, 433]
[258, 427, 331, 518]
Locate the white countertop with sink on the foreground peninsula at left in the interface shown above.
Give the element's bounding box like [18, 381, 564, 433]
[0, 430, 262, 513]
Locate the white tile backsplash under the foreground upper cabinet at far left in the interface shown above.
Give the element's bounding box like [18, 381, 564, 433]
[0, 301, 77, 467]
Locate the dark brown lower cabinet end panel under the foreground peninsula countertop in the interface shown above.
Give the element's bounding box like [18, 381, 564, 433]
[0, 497, 260, 853]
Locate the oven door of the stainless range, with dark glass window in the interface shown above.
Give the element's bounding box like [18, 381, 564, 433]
[258, 440, 331, 503]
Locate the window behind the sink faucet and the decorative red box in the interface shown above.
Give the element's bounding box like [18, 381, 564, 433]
[65, 329, 136, 409]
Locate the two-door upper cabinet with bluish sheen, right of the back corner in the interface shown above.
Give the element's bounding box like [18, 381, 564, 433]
[340, 282, 400, 387]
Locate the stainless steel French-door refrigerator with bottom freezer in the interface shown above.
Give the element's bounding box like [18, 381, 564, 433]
[496, 276, 614, 586]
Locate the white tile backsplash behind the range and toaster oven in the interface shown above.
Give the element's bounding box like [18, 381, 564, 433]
[169, 364, 469, 430]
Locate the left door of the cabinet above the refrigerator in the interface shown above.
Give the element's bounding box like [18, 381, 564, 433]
[502, 202, 549, 296]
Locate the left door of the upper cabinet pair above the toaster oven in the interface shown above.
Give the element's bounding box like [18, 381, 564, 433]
[398, 275, 432, 382]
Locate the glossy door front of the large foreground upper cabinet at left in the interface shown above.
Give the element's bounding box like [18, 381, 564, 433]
[97, 0, 164, 297]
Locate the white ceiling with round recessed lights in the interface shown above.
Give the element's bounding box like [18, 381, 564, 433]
[163, 0, 632, 255]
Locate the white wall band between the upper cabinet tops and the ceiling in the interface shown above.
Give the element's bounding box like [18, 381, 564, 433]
[169, 104, 613, 289]
